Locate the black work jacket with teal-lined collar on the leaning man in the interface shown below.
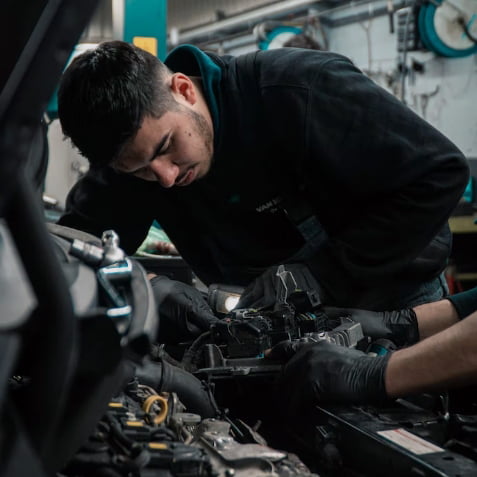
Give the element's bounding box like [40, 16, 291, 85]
[61, 46, 468, 309]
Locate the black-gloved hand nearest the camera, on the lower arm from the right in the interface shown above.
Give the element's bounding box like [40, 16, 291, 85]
[266, 341, 391, 406]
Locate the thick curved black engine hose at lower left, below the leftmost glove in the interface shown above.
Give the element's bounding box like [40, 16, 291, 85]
[136, 359, 218, 418]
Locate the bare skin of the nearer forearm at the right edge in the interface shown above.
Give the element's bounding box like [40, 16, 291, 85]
[385, 310, 477, 397]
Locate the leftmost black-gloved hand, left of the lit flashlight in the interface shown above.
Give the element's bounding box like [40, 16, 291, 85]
[151, 276, 218, 344]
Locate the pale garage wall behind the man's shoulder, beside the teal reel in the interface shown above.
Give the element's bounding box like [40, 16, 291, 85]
[329, 13, 477, 157]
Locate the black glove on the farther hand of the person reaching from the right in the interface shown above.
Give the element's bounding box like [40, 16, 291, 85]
[323, 306, 419, 346]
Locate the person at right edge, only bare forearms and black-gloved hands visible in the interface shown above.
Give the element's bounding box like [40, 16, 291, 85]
[268, 288, 477, 409]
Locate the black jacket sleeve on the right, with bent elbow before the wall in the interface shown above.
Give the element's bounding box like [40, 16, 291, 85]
[305, 58, 469, 279]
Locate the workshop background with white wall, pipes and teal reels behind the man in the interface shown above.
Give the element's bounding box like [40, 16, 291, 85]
[45, 0, 477, 291]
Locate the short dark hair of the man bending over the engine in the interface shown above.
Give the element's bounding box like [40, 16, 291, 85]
[58, 41, 177, 167]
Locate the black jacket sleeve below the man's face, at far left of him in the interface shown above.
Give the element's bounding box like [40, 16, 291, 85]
[58, 168, 153, 255]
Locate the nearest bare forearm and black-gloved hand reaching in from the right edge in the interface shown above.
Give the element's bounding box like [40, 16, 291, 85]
[268, 312, 477, 409]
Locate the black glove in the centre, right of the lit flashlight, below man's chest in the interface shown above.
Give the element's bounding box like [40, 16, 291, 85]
[236, 263, 320, 309]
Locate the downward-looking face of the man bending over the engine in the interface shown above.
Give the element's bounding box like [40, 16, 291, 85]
[113, 106, 213, 187]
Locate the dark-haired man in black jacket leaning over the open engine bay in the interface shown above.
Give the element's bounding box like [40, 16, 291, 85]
[58, 42, 468, 330]
